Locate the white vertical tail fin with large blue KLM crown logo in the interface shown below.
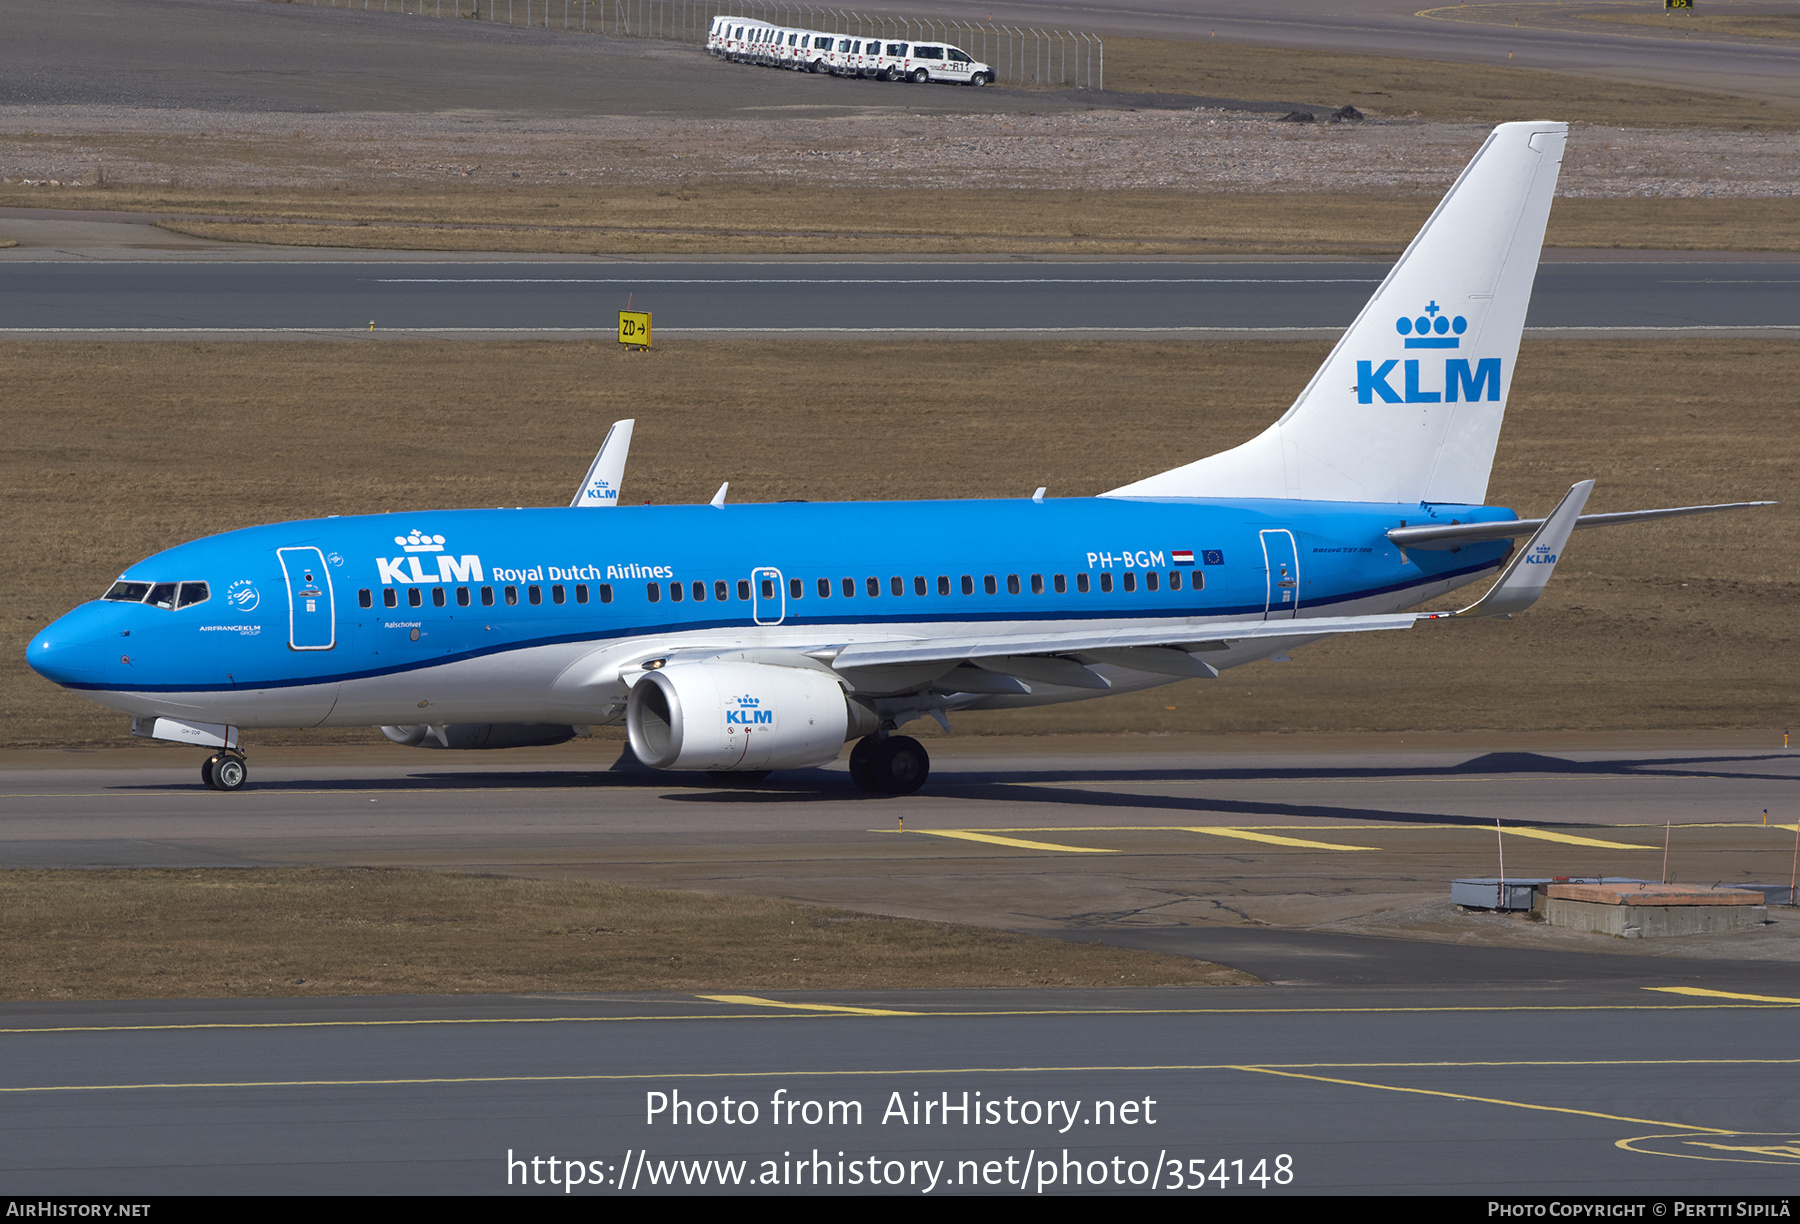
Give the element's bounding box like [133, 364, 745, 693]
[1105, 122, 1568, 504]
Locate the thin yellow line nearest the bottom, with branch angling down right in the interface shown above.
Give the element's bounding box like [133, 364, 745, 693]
[0, 1058, 1800, 1101]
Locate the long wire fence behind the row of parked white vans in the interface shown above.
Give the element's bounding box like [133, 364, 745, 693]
[290, 0, 1107, 90]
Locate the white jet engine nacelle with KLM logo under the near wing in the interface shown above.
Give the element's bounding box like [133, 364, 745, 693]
[625, 661, 877, 770]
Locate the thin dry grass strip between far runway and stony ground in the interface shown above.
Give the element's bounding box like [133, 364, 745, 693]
[147, 193, 1800, 257]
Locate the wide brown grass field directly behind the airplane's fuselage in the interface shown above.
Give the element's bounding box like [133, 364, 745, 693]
[0, 340, 1800, 745]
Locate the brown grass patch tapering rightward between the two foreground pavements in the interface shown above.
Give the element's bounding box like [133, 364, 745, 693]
[0, 868, 1256, 1003]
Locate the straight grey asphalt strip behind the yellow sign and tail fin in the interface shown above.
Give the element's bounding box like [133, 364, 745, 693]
[0, 257, 1800, 340]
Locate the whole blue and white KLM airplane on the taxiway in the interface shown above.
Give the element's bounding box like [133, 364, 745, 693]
[29, 122, 1771, 794]
